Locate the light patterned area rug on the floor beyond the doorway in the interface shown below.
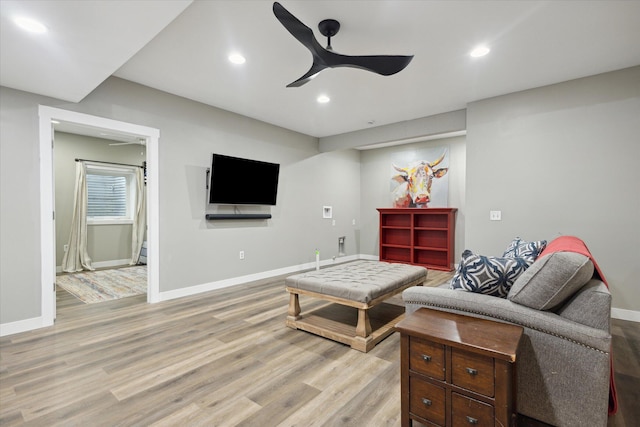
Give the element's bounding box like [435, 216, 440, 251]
[56, 265, 147, 304]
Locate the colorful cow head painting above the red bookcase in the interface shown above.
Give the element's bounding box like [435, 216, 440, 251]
[390, 146, 449, 208]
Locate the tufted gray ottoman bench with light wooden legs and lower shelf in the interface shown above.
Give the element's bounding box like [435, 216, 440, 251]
[285, 261, 427, 353]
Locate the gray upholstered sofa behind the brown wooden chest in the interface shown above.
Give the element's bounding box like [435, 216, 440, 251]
[402, 252, 611, 426]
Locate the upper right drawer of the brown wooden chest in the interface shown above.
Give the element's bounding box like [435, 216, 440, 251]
[451, 348, 495, 397]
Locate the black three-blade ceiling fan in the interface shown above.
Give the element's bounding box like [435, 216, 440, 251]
[273, 2, 413, 87]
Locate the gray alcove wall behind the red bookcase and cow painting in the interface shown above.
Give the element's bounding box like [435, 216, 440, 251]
[360, 137, 466, 262]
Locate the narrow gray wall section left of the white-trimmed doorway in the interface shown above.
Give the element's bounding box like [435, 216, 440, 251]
[0, 87, 48, 323]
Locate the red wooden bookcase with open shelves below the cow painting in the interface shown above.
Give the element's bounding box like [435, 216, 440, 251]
[378, 208, 457, 271]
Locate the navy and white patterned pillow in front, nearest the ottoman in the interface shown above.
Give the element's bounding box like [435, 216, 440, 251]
[451, 249, 534, 298]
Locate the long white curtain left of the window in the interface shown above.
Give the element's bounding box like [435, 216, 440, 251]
[62, 162, 94, 273]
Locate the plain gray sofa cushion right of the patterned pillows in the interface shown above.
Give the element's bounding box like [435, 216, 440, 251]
[507, 252, 593, 310]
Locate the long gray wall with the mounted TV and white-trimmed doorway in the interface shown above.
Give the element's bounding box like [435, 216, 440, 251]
[0, 78, 360, 323]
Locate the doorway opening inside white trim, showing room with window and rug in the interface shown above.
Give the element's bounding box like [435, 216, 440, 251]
[52, 130, 148, 304]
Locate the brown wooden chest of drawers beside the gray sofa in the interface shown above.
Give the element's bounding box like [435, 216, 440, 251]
[396, 308, 523, 427]
